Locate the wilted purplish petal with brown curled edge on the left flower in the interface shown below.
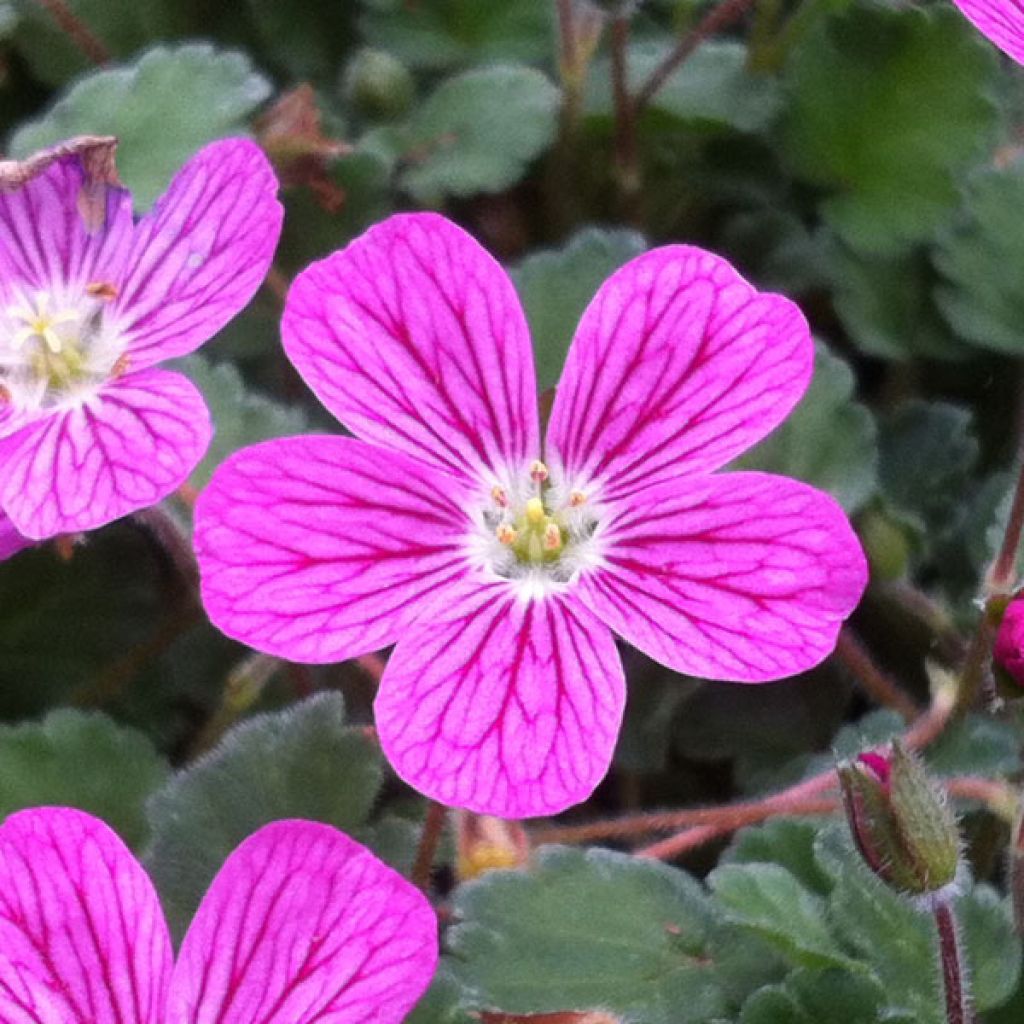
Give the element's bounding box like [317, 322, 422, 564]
[0, 155, 133, 300]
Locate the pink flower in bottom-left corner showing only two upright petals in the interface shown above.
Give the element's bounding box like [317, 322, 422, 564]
[0, 807, 437, 1024]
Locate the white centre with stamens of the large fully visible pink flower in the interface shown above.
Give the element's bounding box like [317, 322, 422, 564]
[471, 462, 607, 597]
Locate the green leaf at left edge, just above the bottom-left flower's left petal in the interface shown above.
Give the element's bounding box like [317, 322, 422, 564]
[0, 710, 168, 849]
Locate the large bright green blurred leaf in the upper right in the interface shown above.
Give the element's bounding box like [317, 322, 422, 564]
[782, 3, 998, 254]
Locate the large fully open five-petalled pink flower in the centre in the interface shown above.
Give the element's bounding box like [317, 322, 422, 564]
[196, 214, 867, 817]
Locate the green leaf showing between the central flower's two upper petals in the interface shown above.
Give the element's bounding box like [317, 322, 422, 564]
[512, 227, 647, 390]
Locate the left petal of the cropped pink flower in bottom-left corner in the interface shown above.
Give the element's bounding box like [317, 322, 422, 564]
[0, 808, 172, 1024]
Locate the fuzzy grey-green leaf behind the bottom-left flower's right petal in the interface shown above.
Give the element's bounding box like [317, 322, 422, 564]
[147, 693, 382, 934]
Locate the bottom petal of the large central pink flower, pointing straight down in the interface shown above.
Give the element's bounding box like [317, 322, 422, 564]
[374, 584, 626, 818]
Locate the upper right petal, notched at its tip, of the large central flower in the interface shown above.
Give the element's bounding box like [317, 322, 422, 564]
[548, 246, 814, 498]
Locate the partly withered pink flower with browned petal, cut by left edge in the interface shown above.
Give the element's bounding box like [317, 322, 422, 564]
[0, 139, 282, 539]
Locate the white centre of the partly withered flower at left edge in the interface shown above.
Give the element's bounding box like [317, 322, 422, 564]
[0, 282, 125, 412]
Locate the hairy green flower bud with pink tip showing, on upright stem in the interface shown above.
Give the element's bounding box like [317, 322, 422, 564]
[838, 743, 961, 897]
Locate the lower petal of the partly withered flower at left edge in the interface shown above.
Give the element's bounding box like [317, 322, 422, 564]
[0, 370, 212, 540]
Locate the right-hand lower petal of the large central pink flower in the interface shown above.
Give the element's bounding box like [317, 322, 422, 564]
[580, 473, 867, 683]
